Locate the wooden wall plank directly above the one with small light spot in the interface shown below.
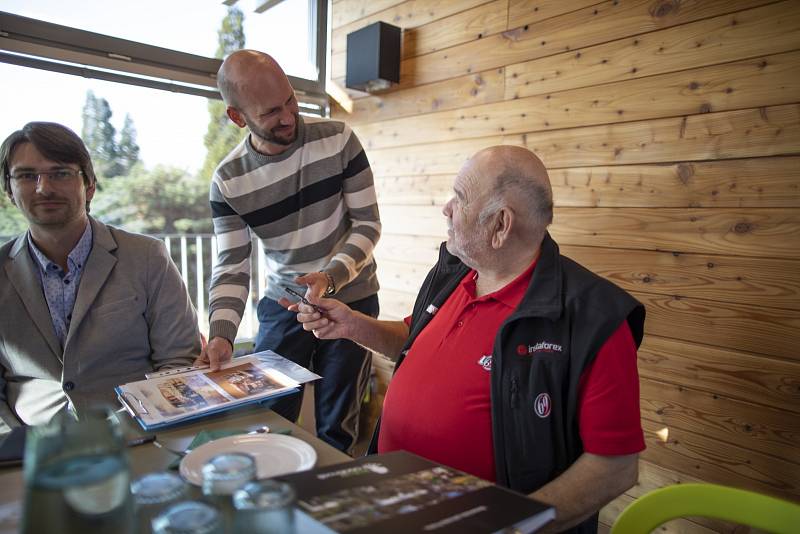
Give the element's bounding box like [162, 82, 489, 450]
[639, 378, 800, 464]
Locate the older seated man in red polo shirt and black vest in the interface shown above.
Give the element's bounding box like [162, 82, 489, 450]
[290, 146, 644, 532]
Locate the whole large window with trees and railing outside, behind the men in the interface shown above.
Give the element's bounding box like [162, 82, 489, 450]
[0, 0, 327, 338]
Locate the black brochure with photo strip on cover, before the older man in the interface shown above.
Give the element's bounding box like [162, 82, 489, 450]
[278, 451, 555, 534]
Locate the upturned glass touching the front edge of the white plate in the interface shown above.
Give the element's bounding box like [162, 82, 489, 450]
[202, 452, 256, 531]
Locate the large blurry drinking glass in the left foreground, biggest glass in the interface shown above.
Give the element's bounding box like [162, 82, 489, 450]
[21, 408, 133, 534]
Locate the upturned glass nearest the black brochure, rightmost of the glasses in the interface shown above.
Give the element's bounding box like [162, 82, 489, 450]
[233, 480, 295, 534]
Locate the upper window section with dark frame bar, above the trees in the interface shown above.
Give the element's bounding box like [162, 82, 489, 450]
[0, 0, 327, 103]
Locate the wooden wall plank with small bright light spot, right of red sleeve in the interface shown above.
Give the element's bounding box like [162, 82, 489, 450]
[641, 419, 800, 501]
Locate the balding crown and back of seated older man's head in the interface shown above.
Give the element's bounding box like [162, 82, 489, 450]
[469, 145, 553, 234]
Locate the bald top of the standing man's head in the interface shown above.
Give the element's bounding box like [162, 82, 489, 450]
[217, 50, 291, 108]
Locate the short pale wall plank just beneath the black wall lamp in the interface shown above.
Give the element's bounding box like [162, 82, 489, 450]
[342, 68, 505, 125]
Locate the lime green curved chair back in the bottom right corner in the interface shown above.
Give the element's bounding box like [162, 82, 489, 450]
[611, 484, 800, 534]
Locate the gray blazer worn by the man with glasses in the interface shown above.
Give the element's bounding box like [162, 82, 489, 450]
[0, 217, 200, 433]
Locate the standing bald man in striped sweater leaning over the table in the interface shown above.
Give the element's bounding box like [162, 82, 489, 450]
[201, 50, 381, 452]
